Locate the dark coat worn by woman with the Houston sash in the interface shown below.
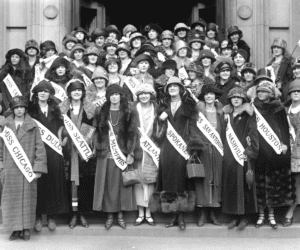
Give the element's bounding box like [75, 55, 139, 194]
[254, 98, 295, 207]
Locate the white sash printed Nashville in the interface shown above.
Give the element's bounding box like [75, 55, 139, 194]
[225, 114, 245, 166]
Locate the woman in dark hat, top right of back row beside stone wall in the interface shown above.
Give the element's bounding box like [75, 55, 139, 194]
[227, 26, 251, 62]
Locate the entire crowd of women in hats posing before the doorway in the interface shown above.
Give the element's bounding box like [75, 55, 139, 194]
[0, 19, 300, 240]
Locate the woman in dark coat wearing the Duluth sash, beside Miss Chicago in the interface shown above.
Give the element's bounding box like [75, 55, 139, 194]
[28, 80, 70, 232]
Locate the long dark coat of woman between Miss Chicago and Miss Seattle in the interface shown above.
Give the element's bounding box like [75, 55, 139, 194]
[29, 100, 70, 215]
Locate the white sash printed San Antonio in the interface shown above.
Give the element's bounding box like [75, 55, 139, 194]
[197, 112, 224, 156]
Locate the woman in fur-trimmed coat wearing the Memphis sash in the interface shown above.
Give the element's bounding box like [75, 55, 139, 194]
[93, 84, 138, 230]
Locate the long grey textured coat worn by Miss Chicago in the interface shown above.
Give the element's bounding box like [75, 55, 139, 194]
[0, 114, 47, 231]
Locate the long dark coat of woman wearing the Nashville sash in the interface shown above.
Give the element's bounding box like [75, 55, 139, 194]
[222, 103, 259, 214]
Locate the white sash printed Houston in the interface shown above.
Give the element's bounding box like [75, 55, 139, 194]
[252, 104, 282, 155]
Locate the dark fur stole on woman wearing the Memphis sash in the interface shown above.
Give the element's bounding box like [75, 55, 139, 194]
[96, 100, 138, 157]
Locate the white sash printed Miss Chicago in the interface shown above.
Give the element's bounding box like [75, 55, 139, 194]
[0, 126, 35, 183]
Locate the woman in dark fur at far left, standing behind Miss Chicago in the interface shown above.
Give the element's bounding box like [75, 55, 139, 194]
[0, 49, 33, 112]
